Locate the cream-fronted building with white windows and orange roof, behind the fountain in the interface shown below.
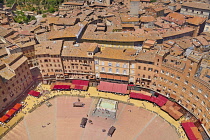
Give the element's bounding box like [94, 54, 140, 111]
[94, 48, 136, 83]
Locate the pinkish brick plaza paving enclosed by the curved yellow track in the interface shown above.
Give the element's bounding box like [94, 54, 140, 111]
[3, 96, 179, 140]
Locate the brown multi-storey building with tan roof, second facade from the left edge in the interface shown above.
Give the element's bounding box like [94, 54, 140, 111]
[35, 40, 65, 83]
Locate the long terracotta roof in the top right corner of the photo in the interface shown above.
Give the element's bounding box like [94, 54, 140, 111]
[182, 2, 210, 10]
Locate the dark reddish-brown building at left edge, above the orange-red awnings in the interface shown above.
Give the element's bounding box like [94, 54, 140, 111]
[0, 53, 33, 111]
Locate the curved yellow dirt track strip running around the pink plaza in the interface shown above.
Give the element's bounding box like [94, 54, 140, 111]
[0, 85, 187, 140]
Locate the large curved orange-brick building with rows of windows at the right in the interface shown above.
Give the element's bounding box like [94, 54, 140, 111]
[157, 51, 210, 131]
